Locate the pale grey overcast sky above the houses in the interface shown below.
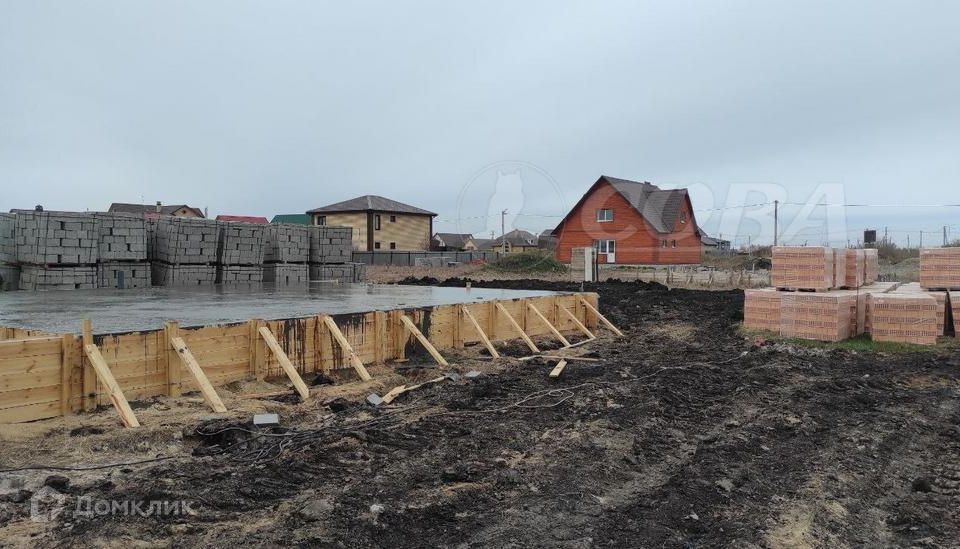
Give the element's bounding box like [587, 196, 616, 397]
[0, 0, 960, 241]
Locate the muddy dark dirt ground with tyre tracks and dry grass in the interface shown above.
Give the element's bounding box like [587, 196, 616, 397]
[0, 280, 960, 547]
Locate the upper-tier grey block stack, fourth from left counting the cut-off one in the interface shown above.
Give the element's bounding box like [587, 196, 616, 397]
[149, 217, 220, 265]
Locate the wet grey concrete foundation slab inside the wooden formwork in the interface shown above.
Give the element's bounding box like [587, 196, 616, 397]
[0, 284, 556, 334]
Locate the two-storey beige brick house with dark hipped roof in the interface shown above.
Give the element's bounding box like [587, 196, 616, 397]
[307, 195, 437, 251]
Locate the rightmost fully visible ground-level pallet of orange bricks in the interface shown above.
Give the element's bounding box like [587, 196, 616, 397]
[869, 292, 939, 345]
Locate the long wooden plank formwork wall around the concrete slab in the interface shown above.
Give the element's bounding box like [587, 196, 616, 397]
[0, 293, 599, 423]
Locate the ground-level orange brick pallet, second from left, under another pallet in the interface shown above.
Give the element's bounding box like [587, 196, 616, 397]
[780, 292, 857, 341]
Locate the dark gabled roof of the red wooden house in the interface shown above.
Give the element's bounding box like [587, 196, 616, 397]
[553, 175, 699, 234]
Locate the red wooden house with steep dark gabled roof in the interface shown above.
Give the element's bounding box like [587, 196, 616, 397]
[553, 175, 703, 265]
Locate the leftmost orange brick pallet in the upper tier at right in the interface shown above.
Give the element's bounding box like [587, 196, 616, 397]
[770, 246, 835, 291]
